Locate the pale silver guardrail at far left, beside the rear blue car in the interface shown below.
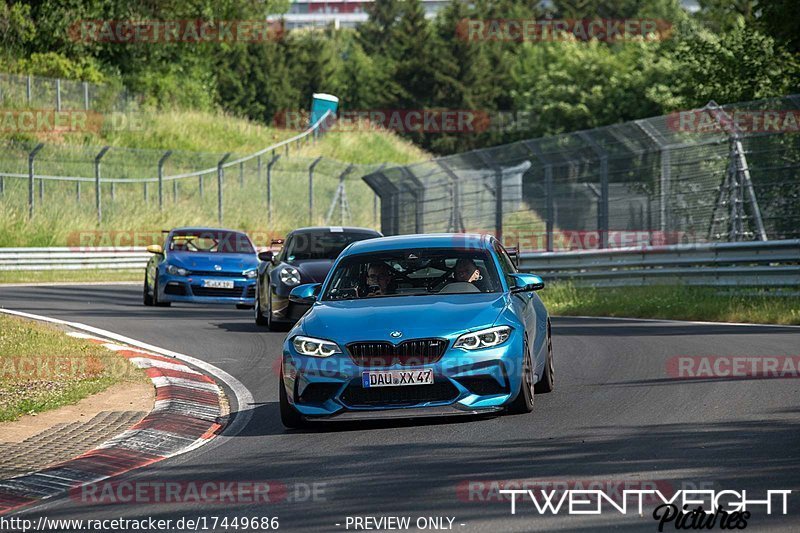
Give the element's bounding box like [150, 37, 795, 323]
[0, 247, 150, 271]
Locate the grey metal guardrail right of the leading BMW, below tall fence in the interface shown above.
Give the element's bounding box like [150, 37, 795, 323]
[520, 239, 800, 287]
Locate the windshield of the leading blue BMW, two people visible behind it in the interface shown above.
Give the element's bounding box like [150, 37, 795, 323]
[322, 249, 502, 300]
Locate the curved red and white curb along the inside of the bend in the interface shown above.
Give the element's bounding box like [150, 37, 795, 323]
[0, 313, 229, 515]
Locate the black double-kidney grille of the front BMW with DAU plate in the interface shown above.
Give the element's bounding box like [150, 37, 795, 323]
[347, 339, 447, 367]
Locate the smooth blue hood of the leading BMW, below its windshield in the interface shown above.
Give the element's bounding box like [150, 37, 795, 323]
[302, 293, 506, 344]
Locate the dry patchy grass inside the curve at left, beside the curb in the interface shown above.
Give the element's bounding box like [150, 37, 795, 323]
[0, 314, 146, 422]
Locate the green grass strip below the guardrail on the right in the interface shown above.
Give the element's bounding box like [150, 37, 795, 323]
[540, 282, 800, 324]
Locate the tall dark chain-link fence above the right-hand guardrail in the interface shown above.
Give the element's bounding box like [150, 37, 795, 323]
[365, 96, 800, 250]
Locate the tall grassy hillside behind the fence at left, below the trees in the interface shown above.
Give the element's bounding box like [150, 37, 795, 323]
[0, 111, 429, 247]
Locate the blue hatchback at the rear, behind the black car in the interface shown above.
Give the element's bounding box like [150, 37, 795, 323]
[144, 228, 258, 309]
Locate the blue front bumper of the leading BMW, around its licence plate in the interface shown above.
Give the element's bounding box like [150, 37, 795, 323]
[281, 331, 523, 419]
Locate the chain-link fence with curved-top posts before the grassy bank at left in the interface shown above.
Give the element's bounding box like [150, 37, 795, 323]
[0, 110, 388, 245]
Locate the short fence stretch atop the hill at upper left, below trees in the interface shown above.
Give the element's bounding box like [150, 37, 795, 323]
[0, 73, 136, 112]
